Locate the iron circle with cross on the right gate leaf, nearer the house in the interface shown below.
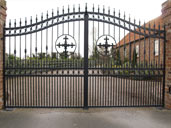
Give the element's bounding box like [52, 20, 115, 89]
[96, 35, 116, 56]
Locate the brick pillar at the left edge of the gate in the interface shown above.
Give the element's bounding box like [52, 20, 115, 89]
[0, 0, 6, 109]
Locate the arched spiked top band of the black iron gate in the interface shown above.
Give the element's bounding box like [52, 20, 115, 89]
[5, 4, 164, 38]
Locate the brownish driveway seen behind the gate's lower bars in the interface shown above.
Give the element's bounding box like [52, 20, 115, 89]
[6, 70, 163, 107]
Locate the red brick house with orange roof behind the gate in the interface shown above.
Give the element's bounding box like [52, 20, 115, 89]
[117, 16, 164, 65]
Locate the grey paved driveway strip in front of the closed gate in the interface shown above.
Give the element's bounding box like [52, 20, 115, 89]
[0, 108, 171, 128]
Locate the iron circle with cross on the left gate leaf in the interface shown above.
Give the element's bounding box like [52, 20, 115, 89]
[55, 34, 76, 57]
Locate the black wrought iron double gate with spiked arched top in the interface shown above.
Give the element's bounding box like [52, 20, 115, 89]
[4, 6, 165, 108]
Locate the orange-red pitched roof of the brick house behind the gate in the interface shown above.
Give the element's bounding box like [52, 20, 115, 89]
[117, 16, 163, 46]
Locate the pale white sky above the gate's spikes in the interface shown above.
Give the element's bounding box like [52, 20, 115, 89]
[6, 0, 166, 22]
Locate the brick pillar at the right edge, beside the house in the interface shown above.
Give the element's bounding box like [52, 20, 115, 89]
[162, 0, 171, 109]
